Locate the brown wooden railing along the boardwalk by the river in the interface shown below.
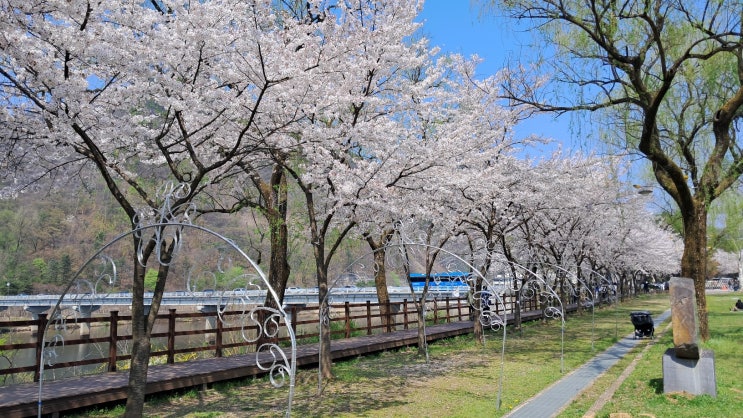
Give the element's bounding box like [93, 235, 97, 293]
[0, 298, 548, 381]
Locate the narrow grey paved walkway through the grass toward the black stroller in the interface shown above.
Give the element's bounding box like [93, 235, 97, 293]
[506, 310, 671, 418]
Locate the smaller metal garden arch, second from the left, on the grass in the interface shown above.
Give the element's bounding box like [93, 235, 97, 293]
[318, 224, 507, 409]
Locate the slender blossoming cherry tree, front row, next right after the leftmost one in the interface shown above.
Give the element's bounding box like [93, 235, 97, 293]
[268, 1, 430, 378]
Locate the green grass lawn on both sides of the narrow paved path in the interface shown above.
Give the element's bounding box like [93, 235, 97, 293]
[71, 293, 743, 418]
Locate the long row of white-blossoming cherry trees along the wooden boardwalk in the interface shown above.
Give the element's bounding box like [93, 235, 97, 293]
[0, 0, 736, 416]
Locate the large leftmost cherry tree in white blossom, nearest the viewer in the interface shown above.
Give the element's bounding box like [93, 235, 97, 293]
[0, 0, 334, 416]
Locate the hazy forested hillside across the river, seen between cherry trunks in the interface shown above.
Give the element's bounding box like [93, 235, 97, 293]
[0, 183, 366, 294]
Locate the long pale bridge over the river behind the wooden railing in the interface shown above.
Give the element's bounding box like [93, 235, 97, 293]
[0, 286, 468, 316]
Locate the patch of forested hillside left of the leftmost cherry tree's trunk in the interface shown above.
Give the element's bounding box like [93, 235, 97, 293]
[0, 183, 120, 293]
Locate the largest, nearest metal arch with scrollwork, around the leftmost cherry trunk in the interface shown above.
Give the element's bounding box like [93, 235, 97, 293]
[38, 185, 297, 417]
